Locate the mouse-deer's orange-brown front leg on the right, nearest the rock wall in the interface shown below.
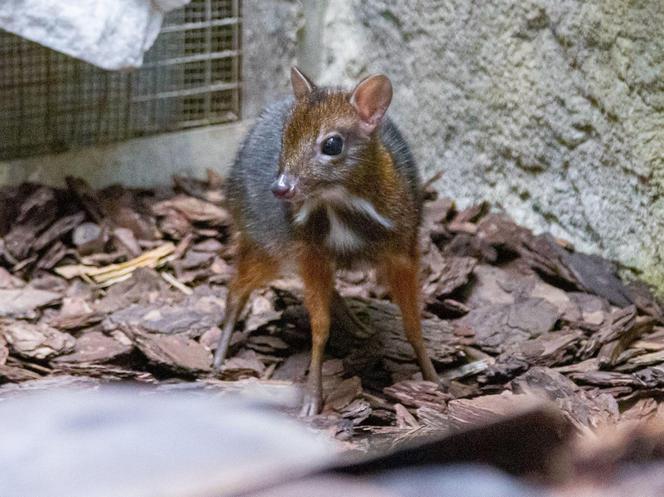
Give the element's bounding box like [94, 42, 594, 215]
[381, 250, 440, 383]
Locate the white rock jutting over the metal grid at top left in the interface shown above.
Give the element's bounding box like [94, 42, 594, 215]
[0, 0, 190, 70]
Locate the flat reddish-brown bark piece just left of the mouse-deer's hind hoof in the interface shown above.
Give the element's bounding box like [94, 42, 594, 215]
[132, 330, 212, 374]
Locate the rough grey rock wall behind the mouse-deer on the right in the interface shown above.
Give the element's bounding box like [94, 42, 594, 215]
[245, 0, 664, 290]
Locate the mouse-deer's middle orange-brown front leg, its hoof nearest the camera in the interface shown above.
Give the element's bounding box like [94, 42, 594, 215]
[299, 248, 334, 416]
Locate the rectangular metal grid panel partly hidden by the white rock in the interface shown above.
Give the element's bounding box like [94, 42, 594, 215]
[0, 0, 242, 159]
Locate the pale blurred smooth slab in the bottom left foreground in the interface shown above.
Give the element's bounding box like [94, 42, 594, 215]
[0, 387, 335, 497]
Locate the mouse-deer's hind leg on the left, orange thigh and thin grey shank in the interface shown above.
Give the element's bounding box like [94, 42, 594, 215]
[214, 240, 278, 369]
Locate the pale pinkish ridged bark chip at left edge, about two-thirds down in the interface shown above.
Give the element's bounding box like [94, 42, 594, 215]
[0, 319, 76, 359]
